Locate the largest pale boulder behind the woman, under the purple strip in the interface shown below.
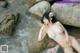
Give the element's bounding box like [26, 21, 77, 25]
[51, 3, 80, 27]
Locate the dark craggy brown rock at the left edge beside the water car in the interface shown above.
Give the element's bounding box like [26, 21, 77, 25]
[0, 13, 19, 34]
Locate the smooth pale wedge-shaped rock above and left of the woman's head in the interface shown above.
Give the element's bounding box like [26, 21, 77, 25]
[29, 1, 50, 17]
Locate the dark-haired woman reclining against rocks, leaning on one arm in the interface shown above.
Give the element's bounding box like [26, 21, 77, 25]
[38, 12, 80, 53]
